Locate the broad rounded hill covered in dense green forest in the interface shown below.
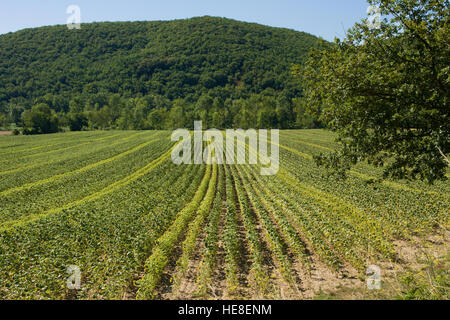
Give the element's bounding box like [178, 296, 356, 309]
[0, 17, 324, 128]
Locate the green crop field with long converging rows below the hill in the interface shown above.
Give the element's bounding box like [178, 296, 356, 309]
[0, 130, 450, 299]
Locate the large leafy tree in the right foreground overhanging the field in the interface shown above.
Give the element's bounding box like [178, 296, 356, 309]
[295, 0, 450, 183]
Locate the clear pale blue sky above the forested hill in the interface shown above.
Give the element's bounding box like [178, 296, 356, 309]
[0, 0, 368, 40]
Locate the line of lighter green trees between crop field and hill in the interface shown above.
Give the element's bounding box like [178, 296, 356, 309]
[7, 94, 323, 134]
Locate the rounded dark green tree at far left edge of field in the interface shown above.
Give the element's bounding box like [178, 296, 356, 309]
[22, 103, 59, 134]
